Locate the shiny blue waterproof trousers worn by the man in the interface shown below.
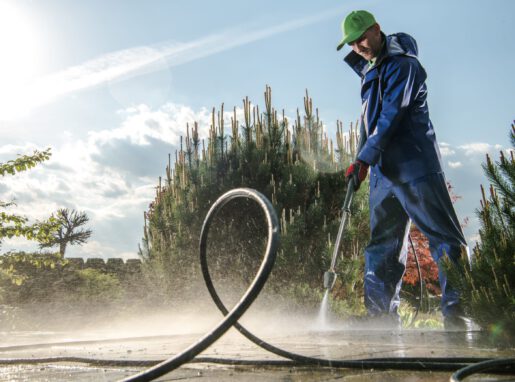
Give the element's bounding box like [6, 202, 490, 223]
[365, 171, 468, 316]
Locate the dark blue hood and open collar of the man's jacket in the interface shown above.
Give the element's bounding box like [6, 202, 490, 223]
[344, 32, 418, 77]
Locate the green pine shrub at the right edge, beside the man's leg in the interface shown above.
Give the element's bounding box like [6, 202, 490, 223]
[447, 125, 515, 341]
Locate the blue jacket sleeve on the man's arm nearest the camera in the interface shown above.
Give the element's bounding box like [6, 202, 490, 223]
[358, 57, 418, 166]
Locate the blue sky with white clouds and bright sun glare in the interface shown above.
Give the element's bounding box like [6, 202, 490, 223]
[0, 0, 515, 258]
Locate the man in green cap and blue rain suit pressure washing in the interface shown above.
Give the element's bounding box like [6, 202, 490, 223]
[337, 11, 468, 328]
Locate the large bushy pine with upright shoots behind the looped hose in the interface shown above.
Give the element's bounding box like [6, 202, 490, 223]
[140, 87, 368, 309]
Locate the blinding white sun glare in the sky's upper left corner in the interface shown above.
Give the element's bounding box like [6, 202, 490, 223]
[0, 2, 39, 118]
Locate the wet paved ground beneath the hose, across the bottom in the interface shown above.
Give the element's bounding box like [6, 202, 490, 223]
[0, 324, 515, 382]
